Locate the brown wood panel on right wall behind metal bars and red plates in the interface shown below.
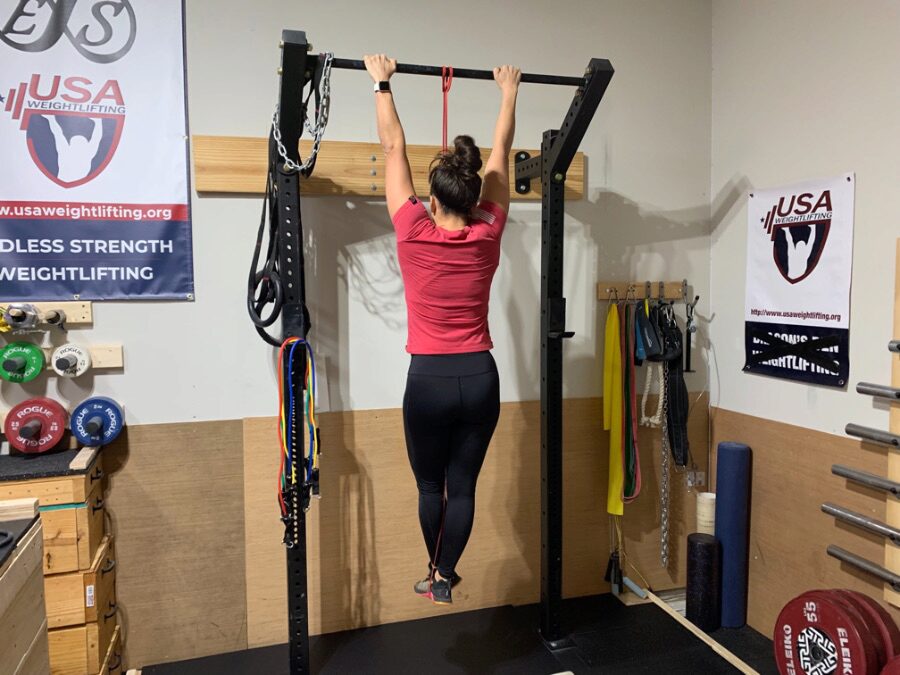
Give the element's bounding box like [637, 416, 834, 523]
[711, 408, 900, 636]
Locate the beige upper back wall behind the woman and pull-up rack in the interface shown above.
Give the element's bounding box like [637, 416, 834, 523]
[0, 0, 711, 424]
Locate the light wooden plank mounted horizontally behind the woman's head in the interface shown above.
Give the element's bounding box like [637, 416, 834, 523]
[192, 136, 585, 200]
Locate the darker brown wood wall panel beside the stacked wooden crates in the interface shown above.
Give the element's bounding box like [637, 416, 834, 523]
[103, 421, 246, 667]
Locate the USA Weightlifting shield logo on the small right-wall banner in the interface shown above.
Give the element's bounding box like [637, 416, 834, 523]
[760, 190, 834, 284]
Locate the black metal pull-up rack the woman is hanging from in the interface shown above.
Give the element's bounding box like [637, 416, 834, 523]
[269, 30, 613, 675]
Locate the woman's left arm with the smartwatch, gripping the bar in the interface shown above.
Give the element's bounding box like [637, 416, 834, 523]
[365, 54, 414, 217]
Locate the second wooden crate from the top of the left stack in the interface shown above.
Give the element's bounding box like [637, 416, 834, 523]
[41, 481, 105, 574]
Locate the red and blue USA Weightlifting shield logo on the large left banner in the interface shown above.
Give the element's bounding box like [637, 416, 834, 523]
[0, 74, 127, 188]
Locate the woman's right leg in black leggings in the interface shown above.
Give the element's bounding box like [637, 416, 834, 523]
[438, 372, 500, 579]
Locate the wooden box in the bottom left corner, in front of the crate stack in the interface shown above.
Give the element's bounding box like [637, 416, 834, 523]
[0, 522, 47, 675]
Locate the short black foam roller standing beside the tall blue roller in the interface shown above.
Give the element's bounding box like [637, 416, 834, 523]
[685, 532, 722, 632]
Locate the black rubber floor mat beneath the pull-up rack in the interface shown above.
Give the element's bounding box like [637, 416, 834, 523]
[143, 595, 774, 675]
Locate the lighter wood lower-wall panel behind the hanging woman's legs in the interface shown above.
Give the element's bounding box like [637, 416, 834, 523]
[244, 395, 708, 647]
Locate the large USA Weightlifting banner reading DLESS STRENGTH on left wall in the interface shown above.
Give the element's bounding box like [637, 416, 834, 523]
[0, 0, 194, 300]
